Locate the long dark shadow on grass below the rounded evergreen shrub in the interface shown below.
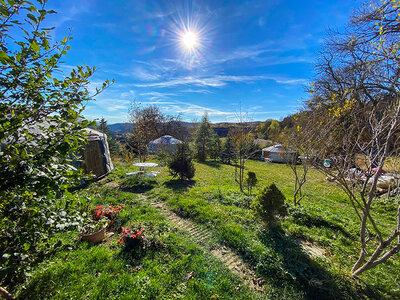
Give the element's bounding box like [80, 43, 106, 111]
[260, 225, 380, 299]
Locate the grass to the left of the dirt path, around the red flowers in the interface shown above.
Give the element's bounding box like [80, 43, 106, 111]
[17, 185, 257, 299]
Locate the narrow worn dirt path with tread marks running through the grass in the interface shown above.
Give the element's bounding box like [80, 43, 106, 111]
[139, 194, 264, 293]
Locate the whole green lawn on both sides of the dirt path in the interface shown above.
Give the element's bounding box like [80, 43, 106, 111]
[17, 161, 400, 299]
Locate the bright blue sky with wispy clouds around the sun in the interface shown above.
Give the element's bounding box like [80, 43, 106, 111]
[44, 0, 355, 124]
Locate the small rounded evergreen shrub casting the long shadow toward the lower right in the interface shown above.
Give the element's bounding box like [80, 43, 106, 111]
[251, 183, 286, 224]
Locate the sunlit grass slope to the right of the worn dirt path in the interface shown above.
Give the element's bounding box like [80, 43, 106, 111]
[145, 161, 400, 298]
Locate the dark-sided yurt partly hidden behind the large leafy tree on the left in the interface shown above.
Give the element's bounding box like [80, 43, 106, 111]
[81, 128, 114, 178]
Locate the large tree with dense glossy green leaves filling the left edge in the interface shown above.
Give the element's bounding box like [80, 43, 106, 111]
[0, 0, 108, 285]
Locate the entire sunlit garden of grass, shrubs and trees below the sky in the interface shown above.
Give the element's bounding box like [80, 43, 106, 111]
[0, 0, 400, 299]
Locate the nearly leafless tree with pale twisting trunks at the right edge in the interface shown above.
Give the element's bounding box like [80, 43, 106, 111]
[307, 1, 400, 276]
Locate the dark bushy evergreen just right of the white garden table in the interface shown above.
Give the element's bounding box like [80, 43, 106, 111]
[168, 143, 196, 180]
